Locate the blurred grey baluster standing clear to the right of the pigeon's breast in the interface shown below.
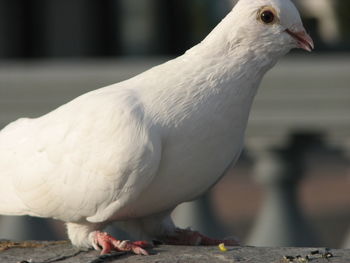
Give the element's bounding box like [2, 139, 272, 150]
[247, 134, 318, 249]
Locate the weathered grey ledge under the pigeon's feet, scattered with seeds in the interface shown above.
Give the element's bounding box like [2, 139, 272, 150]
[0, 241, 350, 263]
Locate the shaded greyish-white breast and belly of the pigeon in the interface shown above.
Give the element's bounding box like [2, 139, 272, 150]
[113, 116, 245, 218]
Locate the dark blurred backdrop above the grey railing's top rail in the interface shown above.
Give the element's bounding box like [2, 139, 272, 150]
[0, 0, 350, 58]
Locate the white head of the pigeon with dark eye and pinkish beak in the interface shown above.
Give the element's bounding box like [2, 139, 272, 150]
[223, 0, 314, 56]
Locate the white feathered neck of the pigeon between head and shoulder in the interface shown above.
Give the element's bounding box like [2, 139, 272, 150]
[142, 15, 279, 127]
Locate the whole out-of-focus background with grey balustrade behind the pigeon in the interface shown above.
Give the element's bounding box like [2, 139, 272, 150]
[0, 0, 350, 248]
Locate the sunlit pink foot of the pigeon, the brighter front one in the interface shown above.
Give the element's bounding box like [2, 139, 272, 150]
[92, 231, 152, 255]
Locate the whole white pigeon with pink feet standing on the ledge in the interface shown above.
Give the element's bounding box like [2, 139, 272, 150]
[0, 0, 313, 254]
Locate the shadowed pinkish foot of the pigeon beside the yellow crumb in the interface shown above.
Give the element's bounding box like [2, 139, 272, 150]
[162, 228, 240, 246]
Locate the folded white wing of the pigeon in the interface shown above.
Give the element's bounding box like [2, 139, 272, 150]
[0, 88, 161, 224]
